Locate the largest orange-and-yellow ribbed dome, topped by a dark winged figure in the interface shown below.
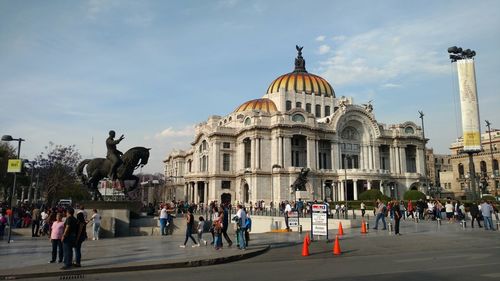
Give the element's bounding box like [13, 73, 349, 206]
[267, 46, 335, 97]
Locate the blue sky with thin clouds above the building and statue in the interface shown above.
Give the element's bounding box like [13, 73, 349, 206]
[0, 0, 500, 173]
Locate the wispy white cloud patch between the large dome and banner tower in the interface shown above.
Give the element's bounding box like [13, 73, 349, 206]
[319, 24, 449, 86]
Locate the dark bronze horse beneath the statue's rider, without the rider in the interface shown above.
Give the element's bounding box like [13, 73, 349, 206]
[76, 147, 151, 200]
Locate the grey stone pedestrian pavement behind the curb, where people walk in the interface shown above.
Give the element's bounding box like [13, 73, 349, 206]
[0, 214, 500, 279]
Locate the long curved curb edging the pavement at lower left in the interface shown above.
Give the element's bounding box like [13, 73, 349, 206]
[0, 245, 271, 280]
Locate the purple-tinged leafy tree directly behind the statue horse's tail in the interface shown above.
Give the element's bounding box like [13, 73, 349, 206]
[36, 142, 89, 206]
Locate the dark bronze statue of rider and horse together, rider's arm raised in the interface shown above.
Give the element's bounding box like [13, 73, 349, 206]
[76, 131, 151, 200]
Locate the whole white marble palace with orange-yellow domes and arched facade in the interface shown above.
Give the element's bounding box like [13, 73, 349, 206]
[164, 46, 425, 206]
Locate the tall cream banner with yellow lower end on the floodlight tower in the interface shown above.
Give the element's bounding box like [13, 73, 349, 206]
[457, 59, 481, 152]
